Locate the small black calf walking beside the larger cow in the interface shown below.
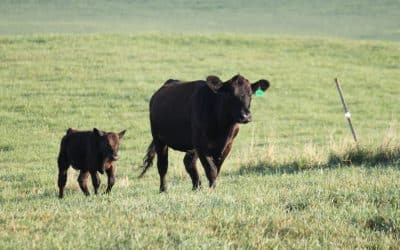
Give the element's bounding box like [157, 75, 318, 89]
[58, 128, 126, 198]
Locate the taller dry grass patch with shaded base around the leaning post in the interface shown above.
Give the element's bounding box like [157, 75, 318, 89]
[239, 126, 400, 174]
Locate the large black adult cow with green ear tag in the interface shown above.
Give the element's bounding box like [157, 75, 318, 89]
[140, 75, 269, 192]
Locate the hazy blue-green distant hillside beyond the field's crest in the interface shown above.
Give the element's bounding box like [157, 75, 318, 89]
[0, 0, 400, 41]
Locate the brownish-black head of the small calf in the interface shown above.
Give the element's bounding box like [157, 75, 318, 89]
[93, 128, 126, 162]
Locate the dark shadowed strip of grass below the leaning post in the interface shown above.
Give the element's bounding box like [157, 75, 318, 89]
[231, 146, 400, 175]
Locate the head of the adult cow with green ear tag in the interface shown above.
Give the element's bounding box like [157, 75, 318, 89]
[207, 75, 269, 123]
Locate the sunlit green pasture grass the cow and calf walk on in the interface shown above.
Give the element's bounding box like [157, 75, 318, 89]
[0, 33, 400, 249]
